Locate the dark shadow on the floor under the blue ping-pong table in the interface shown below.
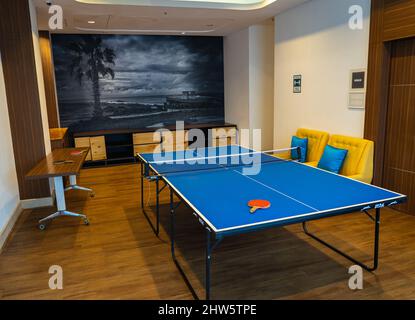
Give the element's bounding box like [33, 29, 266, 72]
[139, 205, 358, 299]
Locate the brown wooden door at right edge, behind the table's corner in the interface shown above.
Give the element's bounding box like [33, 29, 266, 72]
[383, 38, 415, 215]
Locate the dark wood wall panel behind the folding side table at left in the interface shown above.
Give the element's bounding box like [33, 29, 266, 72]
[0, 1, 50, 199]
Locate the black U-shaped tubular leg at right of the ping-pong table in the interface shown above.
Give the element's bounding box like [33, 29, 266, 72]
[303, 208, 380, 272]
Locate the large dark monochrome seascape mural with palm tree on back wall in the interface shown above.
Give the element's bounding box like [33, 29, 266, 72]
[52, 34, 224, 132]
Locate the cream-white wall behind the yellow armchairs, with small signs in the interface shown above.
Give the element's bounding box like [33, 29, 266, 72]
[274, 0, 370, 148]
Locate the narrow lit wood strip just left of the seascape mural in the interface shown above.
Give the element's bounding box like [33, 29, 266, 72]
[39, 31, 60, 128]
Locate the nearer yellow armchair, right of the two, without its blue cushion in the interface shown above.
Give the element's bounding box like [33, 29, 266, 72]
[328, 135, 374, 183]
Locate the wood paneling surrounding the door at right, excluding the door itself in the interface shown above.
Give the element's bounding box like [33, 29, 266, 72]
[365, 0, 415, 185]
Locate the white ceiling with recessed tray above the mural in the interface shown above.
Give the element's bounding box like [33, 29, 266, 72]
[34, 0, 308, 36]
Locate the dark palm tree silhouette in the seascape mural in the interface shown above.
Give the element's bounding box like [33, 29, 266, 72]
[68, 35, 116, 118]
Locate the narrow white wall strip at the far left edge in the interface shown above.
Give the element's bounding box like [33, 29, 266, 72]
[0, 56, 20, 249]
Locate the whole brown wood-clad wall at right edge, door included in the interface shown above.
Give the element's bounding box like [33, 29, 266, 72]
[365, 0, 415, 213]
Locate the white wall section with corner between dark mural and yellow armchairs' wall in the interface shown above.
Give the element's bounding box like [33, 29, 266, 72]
[224, 20, 274, 150]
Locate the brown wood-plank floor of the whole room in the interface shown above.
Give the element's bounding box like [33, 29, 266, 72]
[0, 165, 415, 299]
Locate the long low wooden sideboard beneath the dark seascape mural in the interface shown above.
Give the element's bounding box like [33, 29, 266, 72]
[73, 123, 237, 166]
